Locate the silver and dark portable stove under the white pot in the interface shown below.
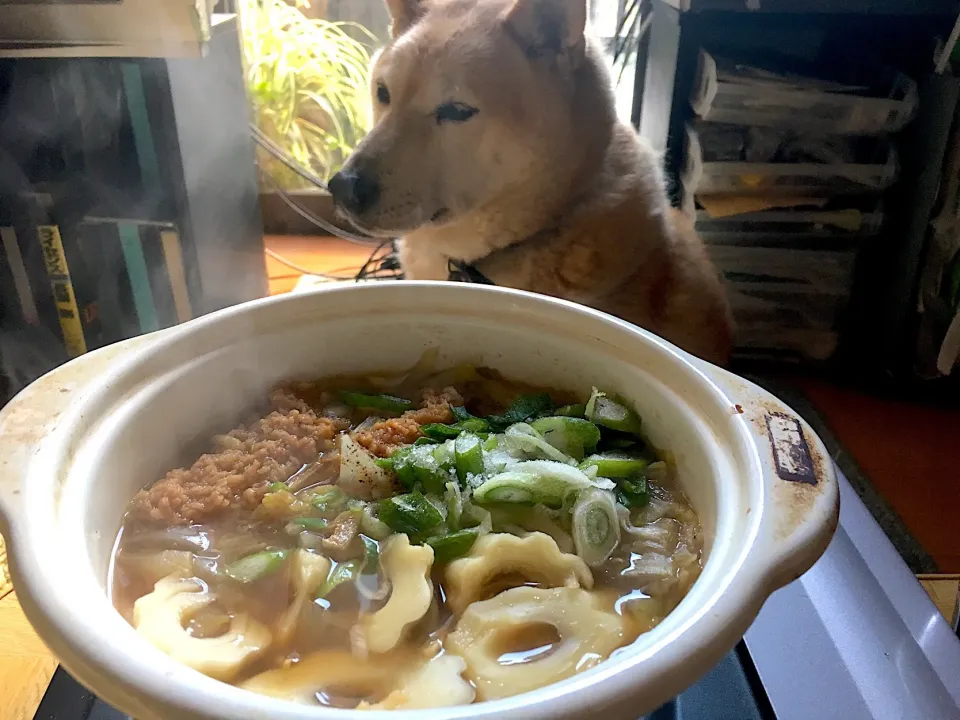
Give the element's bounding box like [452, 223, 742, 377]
[34, 477, 960, 720]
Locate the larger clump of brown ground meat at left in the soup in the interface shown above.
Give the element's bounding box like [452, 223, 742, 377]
[132, 392, 343, 525]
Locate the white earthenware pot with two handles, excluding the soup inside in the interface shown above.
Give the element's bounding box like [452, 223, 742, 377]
[0, 282, 839, 720]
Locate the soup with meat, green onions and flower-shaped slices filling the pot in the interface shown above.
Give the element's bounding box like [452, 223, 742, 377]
[112, 353, 702, 708]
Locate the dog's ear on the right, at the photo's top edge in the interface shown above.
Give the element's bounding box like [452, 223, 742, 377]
[504, 0, 587, 65]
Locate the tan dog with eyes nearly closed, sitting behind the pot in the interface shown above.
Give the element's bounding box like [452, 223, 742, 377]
[330, 0, 731, 363]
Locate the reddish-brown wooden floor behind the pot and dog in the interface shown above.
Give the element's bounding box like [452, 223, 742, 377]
[267, 236, 960, 573]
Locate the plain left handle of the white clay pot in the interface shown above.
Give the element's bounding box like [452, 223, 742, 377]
[0, 331, 163, 546]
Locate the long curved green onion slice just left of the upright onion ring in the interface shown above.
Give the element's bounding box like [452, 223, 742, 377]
[473, 460, 593, 507]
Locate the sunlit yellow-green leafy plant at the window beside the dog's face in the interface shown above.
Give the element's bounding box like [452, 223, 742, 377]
[239, 0, 376, 189]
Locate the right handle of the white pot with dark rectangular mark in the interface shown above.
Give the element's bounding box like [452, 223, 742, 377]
[698, 361, 840, 591]
